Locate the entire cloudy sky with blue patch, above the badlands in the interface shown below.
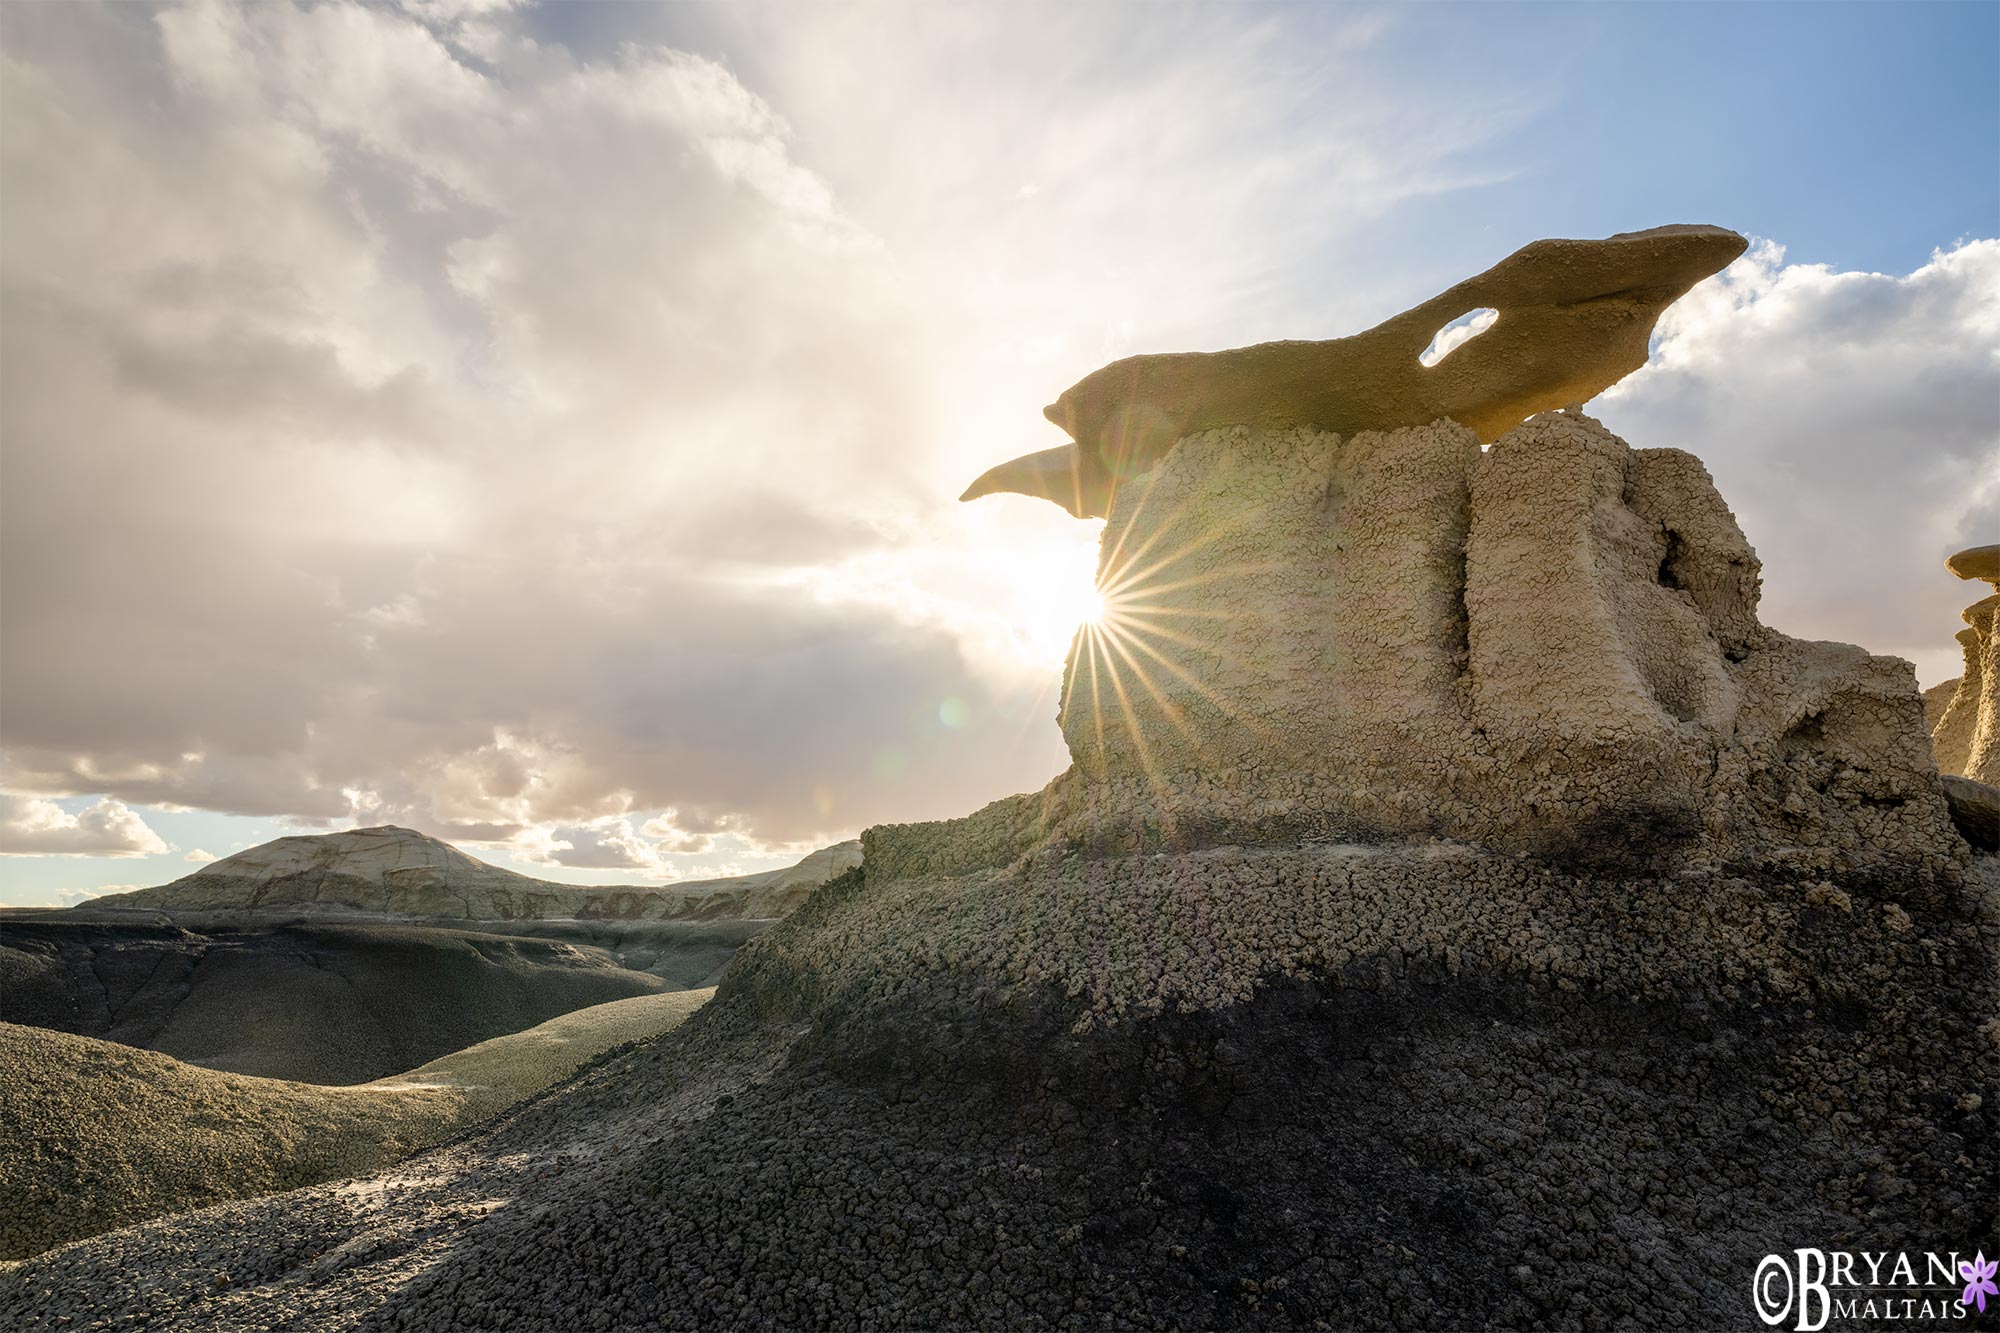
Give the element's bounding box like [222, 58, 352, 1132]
[0, 0, 2000, 905]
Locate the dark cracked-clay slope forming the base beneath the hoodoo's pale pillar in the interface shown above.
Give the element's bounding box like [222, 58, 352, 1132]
[0, 831, 2000, 1329]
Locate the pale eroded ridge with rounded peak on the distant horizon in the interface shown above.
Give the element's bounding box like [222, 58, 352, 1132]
[80, 825, 862, 921]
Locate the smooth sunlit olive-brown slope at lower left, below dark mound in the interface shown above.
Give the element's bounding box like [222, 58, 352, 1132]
[0, 991, 710, 1259]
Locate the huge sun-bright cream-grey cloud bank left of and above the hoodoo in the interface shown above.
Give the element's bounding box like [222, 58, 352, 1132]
[0, 0, 1510, 840]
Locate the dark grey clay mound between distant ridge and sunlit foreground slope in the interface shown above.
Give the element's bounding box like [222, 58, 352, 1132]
[0, 917, 670, 1083]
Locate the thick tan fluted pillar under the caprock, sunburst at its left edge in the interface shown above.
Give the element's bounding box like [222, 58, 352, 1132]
[1062, 412, 1962, 875]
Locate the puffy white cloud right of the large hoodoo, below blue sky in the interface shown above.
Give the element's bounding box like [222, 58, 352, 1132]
[1598, 240, 2000, 683]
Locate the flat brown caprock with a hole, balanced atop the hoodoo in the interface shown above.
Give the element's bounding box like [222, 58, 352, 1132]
[960, 226, 1748, 518]
